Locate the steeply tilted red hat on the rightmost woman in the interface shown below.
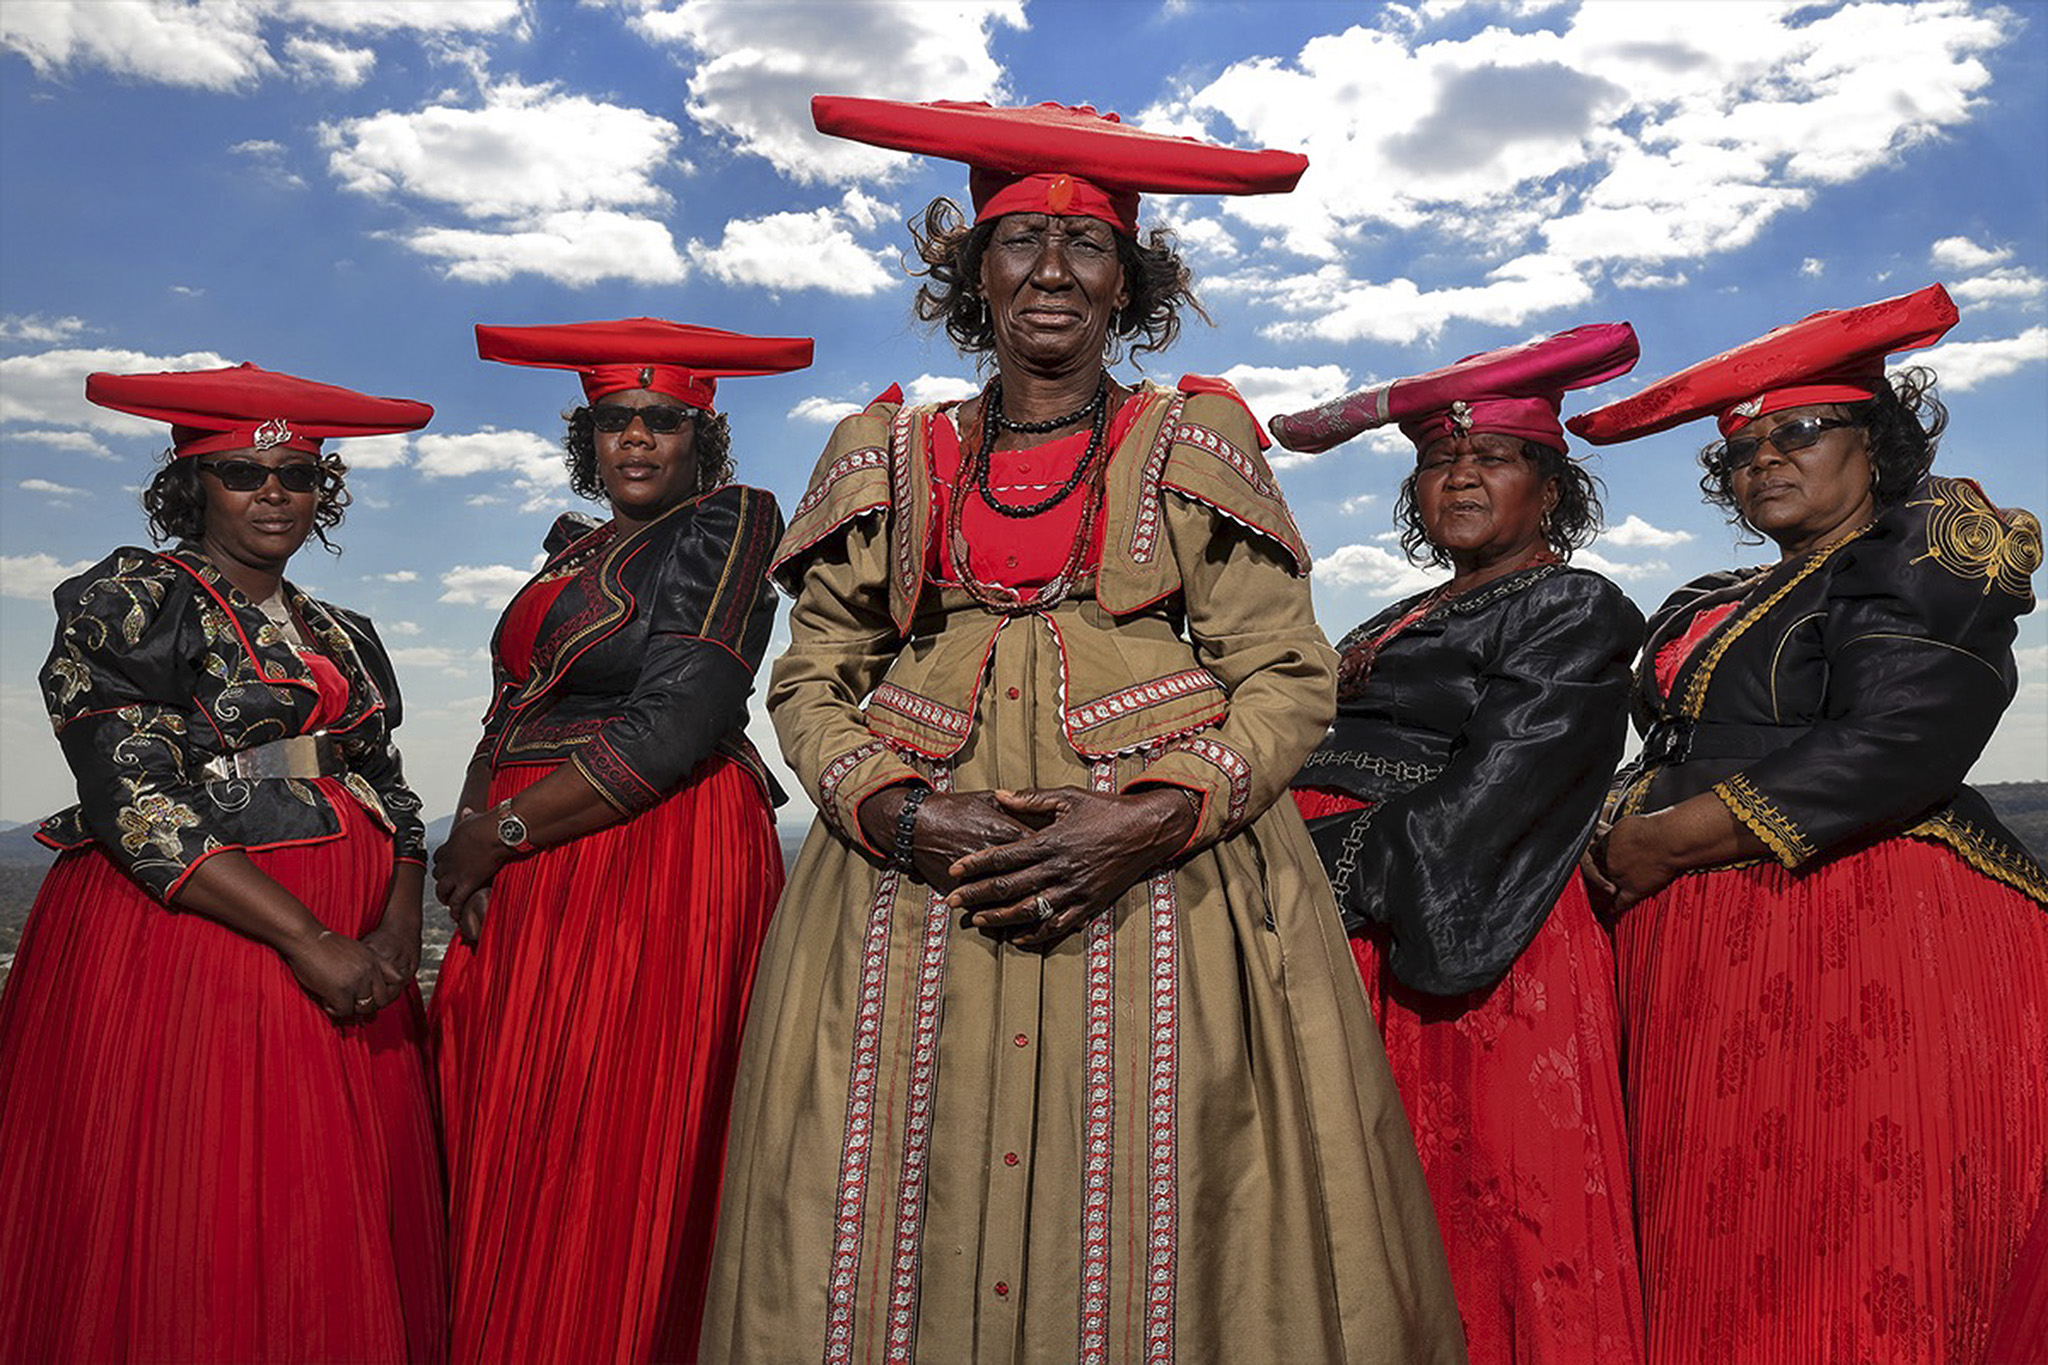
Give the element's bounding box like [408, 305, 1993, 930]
[1565, 284, 1958, 446]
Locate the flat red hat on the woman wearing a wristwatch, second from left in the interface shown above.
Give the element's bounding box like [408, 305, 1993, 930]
[477, 317, 811, 411]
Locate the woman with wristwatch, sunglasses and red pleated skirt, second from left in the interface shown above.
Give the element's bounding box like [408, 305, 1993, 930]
[434, 317, 811, 1361]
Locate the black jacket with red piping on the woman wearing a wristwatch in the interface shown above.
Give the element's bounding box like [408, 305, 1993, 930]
[477, 483, 782, 814]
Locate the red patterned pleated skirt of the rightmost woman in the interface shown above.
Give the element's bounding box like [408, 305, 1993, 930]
[1616, 839, 2048, 1365]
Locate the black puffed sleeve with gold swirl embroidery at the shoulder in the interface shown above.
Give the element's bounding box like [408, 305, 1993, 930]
[1712, 477, 2042, 868]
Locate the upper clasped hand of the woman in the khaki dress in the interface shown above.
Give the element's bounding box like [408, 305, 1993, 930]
[946, 786, 1196, 948]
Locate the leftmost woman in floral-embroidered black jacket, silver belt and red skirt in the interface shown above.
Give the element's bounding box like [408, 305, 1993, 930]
[0, 364, 446, 1363]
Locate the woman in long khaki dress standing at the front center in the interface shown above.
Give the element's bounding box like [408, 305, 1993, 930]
[702, 98, 1464, 1363]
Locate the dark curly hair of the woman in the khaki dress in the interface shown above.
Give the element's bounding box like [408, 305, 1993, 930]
[903, 194, 1214, 364]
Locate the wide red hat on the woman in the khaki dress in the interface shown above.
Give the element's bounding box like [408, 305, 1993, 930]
[811, 94, 1309, 235]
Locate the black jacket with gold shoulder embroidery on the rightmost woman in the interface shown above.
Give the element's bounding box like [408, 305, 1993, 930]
[1618, 475, 2048, 905]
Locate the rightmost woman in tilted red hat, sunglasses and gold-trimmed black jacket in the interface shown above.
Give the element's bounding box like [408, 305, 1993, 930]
[1571, 284, 2048, 1363]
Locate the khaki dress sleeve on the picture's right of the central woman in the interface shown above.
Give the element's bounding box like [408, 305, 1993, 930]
[1126, 395, 1337, 853]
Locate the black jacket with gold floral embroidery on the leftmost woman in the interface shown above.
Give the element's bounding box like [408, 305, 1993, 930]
[37, 546, 426, 898]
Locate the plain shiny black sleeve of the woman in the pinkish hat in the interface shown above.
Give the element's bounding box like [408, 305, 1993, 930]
[1309, 573, 1642, 995]
